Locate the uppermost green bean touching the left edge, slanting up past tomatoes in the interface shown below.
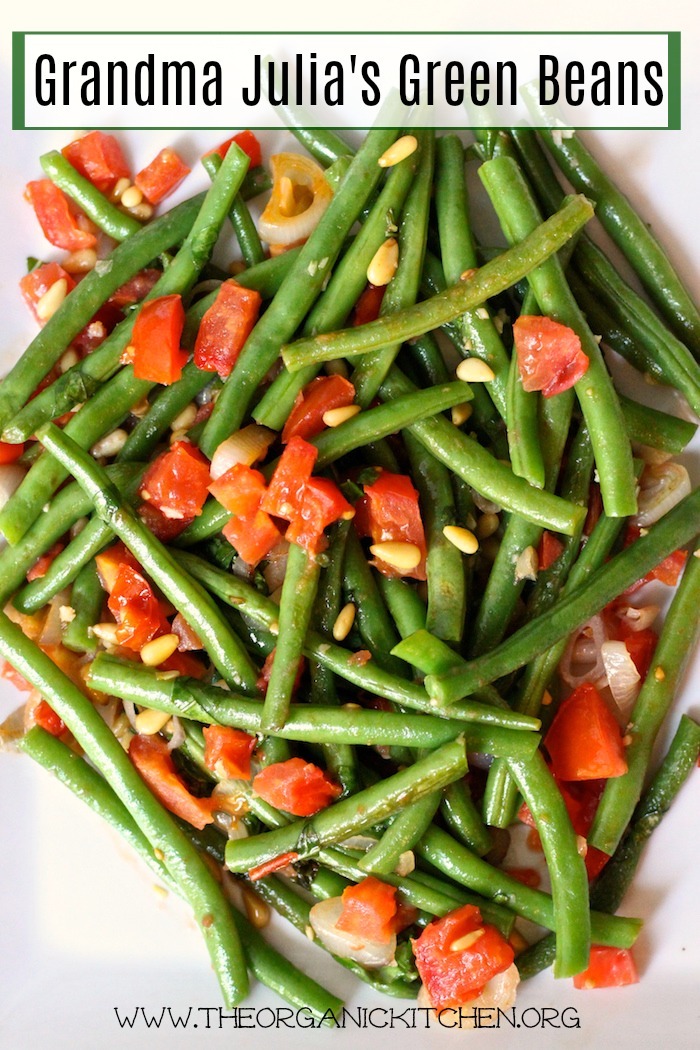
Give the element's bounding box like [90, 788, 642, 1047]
[0, 194, 204, 441]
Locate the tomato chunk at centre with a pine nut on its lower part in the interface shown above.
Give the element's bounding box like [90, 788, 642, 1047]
[355, 470, 427, 580]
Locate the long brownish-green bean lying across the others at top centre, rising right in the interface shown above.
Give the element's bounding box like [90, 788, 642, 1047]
[282, 197, 593, 372]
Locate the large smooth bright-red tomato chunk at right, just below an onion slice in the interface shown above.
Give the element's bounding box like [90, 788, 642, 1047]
[545, 681, 628, 780]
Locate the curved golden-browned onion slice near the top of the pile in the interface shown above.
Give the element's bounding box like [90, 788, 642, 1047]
[258, 153, 333, 246]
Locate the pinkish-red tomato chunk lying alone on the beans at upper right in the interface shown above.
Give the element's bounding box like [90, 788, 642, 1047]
[513, 315, 589, 397]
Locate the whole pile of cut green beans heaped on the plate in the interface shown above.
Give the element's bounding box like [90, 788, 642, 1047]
[0, 114, 700, 1023]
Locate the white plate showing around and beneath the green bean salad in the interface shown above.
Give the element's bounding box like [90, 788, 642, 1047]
[0, 124, 700, 1050]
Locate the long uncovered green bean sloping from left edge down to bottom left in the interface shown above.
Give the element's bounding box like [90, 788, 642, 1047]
[0, 613, 248, 1006]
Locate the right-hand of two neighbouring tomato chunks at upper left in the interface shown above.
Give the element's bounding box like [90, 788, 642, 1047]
[194, 280, 262, 379]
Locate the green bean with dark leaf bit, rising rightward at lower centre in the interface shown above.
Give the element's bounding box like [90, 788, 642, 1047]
[221, 739, 467, 872]
